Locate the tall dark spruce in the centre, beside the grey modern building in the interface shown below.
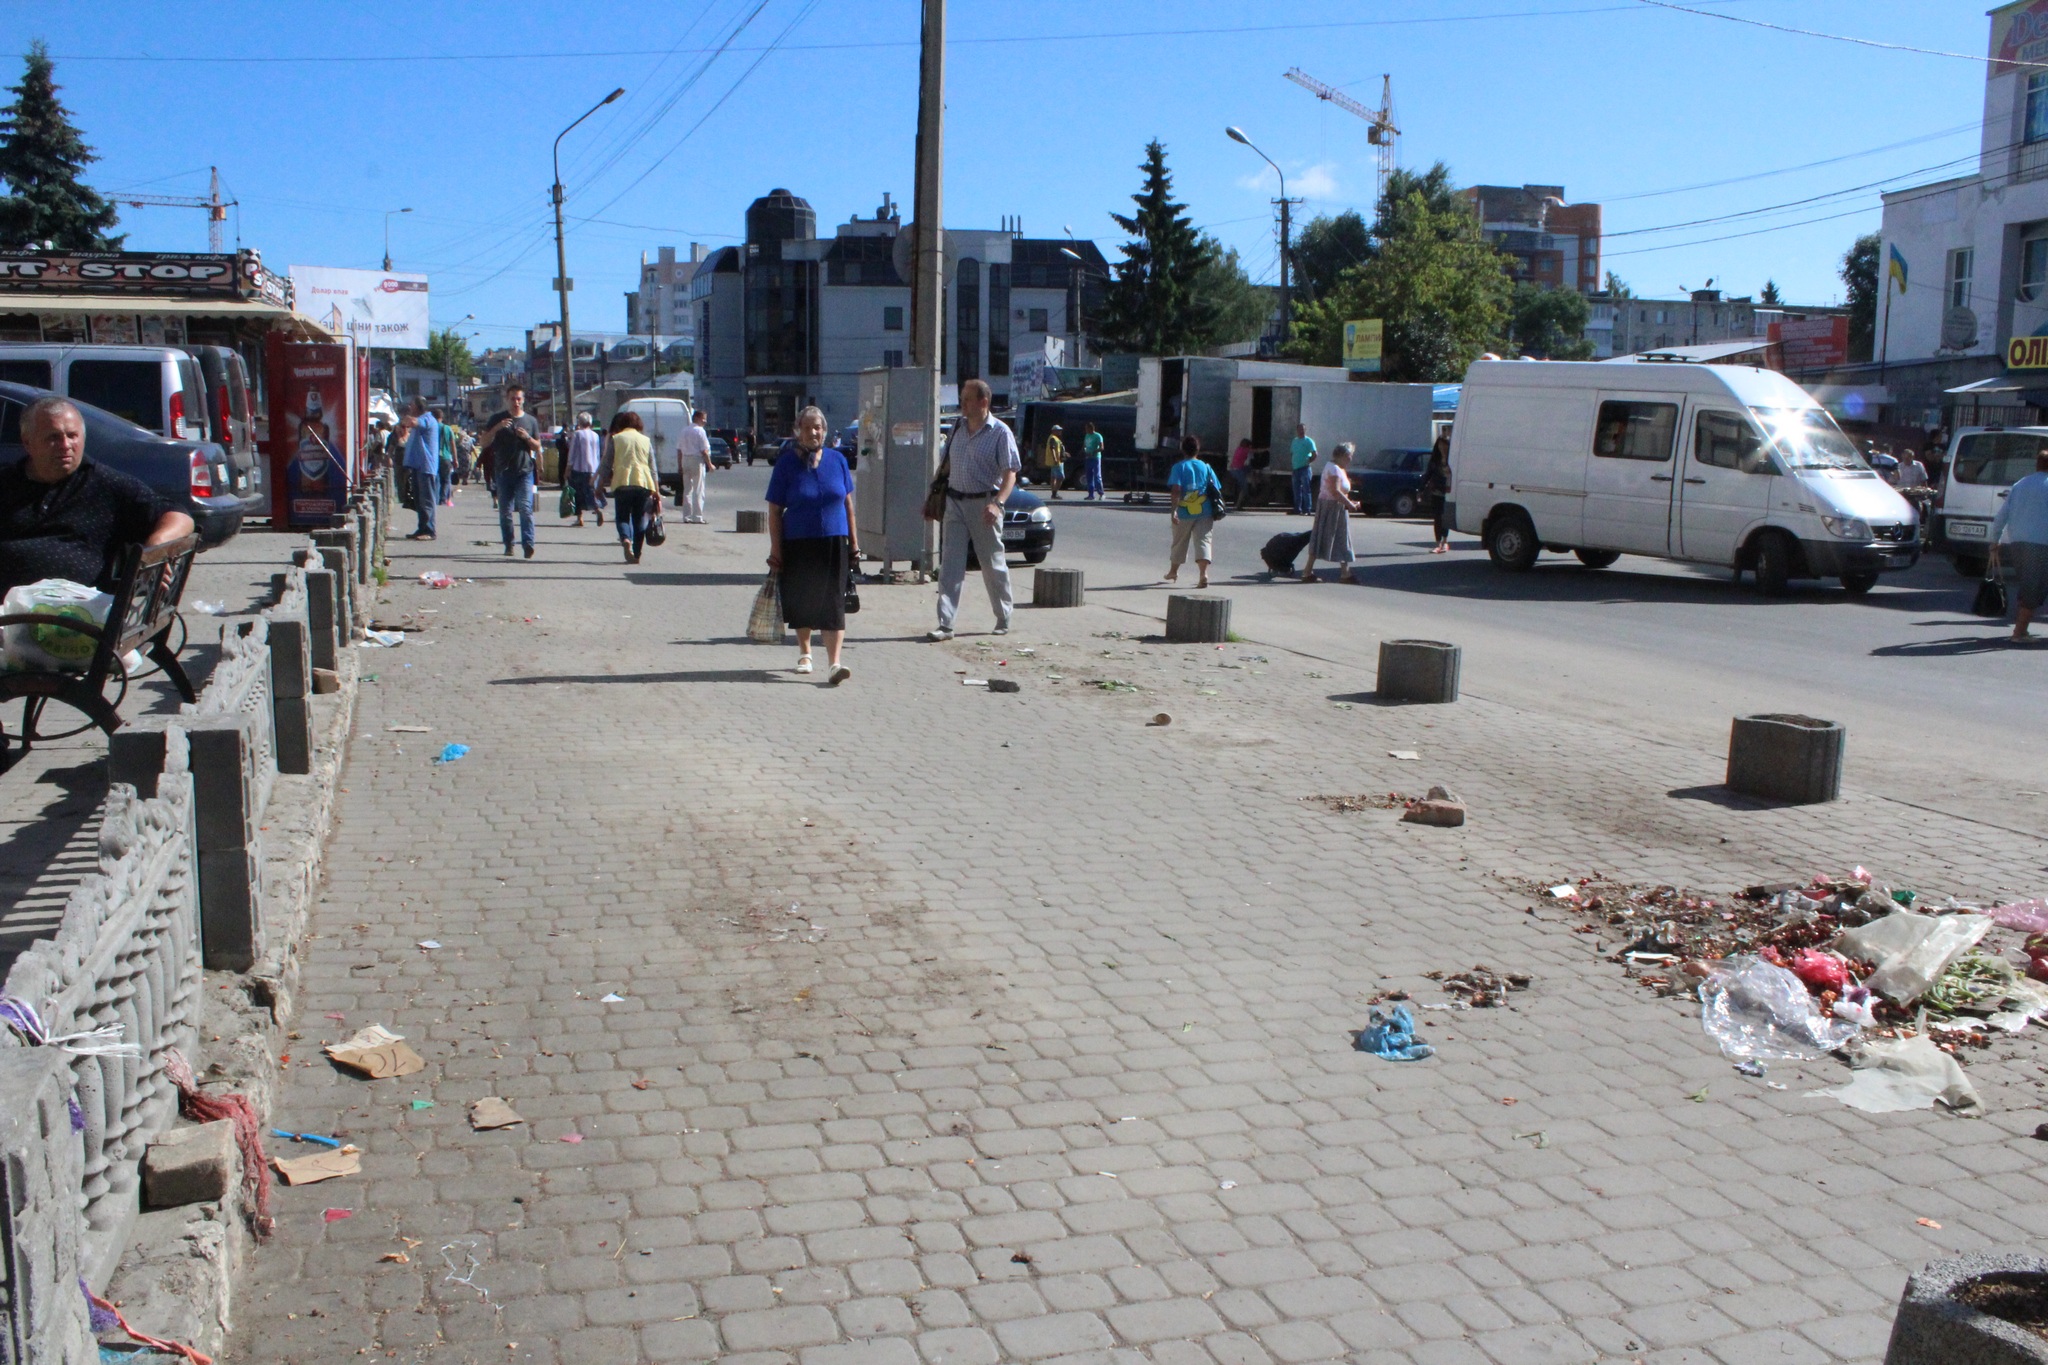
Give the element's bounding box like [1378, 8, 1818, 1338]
[1092, 139, 1212, 356]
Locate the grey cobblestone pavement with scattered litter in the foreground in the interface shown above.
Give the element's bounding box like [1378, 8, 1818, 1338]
[231, 481, 2048, 1365]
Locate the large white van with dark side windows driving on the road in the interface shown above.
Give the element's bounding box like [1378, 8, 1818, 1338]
[1450, 360, 1919, 593]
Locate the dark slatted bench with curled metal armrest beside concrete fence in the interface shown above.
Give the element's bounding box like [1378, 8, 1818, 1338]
[0, 534, 199, 774]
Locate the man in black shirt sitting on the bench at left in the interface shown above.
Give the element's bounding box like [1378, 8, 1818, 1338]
[0, 395, 193, 593]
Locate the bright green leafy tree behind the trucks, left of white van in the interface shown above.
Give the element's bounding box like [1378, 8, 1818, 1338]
[1288, 162, 1513, 383]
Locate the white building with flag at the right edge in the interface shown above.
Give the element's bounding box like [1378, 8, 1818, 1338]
[1874, 0, 2048, 426]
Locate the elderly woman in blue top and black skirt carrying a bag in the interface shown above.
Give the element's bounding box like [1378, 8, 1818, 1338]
[768, 407, 860, 688]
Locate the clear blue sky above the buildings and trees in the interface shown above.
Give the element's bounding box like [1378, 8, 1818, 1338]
[12, 0, 1987, 346]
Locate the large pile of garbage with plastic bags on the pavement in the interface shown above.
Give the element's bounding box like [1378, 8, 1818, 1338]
[1518, 868, 2048, 1113]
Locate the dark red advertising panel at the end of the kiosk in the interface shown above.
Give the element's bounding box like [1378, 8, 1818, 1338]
[266, 332, 360, 528]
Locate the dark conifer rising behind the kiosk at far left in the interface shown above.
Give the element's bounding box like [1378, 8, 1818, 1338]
[0, 39, 125, 252]
